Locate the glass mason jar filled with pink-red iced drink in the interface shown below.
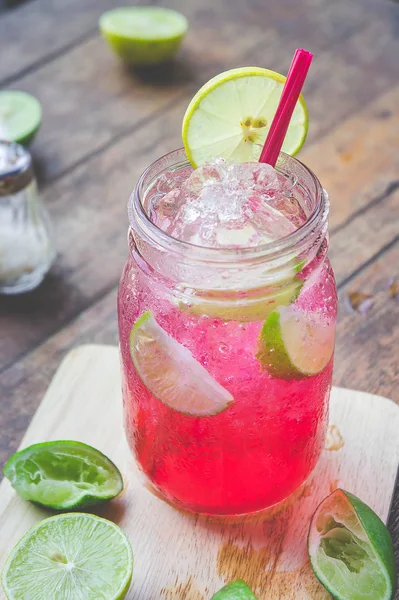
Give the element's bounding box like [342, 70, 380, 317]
[118, 150, 337, 515]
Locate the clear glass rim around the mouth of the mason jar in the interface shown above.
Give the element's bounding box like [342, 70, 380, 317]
[128, 148, 329, 264]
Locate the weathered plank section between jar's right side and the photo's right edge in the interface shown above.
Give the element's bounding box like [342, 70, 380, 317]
[334, 243, 399, 404]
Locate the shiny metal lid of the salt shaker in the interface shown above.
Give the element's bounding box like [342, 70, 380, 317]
[0, 140, 34, 197]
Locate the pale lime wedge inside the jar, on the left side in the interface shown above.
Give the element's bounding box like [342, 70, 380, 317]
[130, 312, 233, 417]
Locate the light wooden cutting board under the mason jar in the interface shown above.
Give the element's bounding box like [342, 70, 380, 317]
[0, 346, 399, 600]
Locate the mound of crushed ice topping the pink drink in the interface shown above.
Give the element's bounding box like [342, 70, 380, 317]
[150, 159, 306, 248]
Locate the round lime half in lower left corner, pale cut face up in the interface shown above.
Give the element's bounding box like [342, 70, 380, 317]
[2, 513, 133, 600]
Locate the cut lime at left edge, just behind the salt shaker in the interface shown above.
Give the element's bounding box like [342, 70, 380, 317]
[0, 90, 42, 146]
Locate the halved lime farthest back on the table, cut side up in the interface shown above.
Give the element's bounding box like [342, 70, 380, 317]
[99, 6, 188, 65]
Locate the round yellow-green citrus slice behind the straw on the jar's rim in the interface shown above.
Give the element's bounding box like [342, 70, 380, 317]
[182, 67, 308, 168]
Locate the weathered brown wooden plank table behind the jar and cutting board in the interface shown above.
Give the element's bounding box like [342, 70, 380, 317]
[0, 0, 399, 580]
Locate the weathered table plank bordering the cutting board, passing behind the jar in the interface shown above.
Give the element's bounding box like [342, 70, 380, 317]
[0, 229, 399, 462]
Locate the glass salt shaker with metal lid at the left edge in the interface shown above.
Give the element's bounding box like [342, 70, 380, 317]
[0, 141, 56, 294]
